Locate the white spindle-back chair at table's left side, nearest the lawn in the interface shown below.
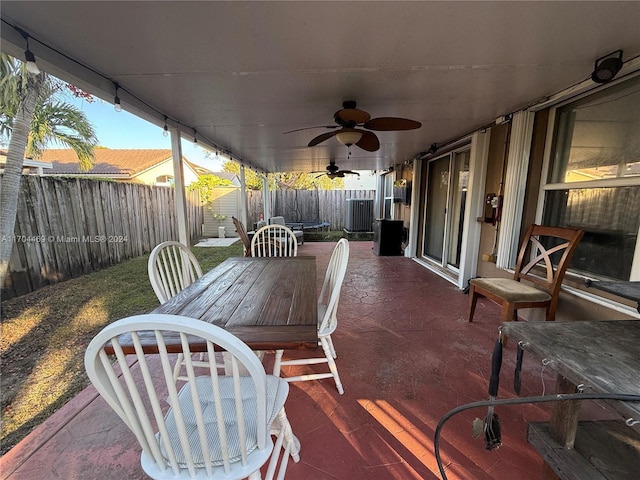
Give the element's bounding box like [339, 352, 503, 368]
[148, 240, 202, 303]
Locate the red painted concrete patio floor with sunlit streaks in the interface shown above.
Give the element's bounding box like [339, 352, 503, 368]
[0, 242, 600, 480]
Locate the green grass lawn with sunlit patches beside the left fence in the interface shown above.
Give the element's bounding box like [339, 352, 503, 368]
[0, 242, 243, 454]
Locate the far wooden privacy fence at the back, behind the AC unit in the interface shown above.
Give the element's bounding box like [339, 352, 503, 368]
[247, 190, 375, 230]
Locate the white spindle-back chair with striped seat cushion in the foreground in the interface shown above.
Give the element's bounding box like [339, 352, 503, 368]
[85, 314, 300, 480]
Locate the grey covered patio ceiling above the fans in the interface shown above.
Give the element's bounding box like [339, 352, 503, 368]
[0, 0, 640, 172]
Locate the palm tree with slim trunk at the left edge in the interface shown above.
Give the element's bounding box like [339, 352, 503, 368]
[0, 54, 97, 287]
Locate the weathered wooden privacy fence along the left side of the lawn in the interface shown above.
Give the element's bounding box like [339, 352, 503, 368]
[0, 175, 202, 299]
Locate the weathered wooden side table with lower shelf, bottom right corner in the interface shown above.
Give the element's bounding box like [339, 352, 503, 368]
[502, 320, 640, 480]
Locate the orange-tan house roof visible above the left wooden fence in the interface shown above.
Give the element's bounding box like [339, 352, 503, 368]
[40, 148, 194, 177]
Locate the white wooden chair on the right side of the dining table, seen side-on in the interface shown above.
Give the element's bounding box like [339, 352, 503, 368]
[273, 238, 349, 395]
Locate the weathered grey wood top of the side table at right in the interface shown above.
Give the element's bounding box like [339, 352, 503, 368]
[501, 320, 640, 420]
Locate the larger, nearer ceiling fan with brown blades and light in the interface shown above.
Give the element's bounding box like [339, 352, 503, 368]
[294, 100, 422, 152]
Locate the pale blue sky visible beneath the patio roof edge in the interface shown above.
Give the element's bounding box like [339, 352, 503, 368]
[63, 95, 376, 190]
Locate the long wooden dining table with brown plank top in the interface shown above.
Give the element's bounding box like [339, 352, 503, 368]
[112, 256, 318, 354]
